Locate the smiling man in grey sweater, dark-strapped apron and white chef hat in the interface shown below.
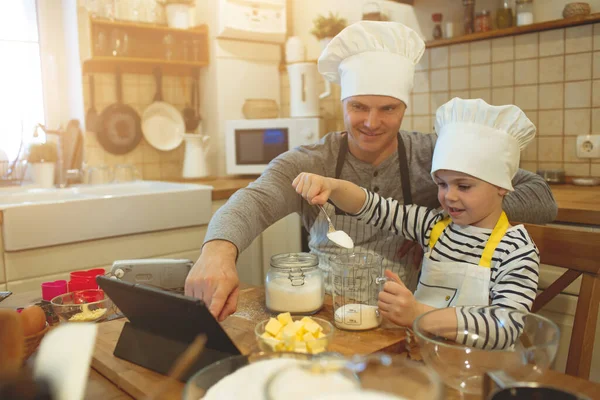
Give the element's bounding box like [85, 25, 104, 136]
[185, 21, 556, 320]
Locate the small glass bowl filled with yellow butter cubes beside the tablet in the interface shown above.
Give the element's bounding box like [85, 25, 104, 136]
[254, 313, 335, 354]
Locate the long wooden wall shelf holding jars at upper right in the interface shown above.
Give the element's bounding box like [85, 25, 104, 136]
[426, 13, 600, 48]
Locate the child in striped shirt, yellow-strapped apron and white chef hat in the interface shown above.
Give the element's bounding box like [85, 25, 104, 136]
[293, 98, 539, 348]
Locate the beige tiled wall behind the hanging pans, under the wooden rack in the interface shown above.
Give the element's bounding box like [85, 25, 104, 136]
[83, 74, 191, 180]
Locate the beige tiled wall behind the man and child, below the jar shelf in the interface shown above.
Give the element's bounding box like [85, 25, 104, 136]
[281, 24, 600, 176]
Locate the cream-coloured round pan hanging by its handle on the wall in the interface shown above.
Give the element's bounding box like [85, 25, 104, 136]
[142, 68, 185, 151]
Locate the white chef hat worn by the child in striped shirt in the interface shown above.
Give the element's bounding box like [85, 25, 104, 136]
[431, 98, 536, 191]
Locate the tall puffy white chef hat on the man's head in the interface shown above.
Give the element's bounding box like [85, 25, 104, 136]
[319, 21, 425, 104]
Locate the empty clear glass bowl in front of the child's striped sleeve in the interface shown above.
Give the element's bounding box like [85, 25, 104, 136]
[413, 307, 560, 394]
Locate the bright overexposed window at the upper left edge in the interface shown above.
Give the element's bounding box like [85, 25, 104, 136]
[0, 0, 45, 162]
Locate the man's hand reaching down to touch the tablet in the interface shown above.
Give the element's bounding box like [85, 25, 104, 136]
[185, 240, 240, 321]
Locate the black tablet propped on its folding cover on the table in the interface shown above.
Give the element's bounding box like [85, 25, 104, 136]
[96, 276, 241, 381]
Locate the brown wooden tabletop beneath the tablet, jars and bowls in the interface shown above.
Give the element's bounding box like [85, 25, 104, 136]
[0, 288, 600, 400]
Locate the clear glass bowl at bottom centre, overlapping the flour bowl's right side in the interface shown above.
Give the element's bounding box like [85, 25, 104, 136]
[264, 353, 444, 400]
